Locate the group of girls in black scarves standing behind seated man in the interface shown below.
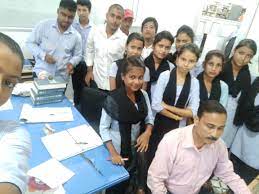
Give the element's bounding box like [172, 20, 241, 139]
[100, 16, 259, 193]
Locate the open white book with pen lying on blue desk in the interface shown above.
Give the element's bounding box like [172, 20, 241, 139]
[41, 125, 103, 161]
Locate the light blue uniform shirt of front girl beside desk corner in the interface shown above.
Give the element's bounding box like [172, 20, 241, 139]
[100, 90, 154, 153]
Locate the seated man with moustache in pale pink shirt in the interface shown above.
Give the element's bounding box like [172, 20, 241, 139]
[147, 100, 251, 194]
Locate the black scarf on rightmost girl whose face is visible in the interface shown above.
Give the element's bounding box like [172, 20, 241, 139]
[220, 58, 251, 98]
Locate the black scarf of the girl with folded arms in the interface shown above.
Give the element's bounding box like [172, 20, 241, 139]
[154, 68, 191, 134]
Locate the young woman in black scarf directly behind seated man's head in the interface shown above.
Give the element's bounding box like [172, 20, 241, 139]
[197, 50, 228, 107]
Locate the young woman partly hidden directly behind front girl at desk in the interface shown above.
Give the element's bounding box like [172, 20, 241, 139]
[109, 32, 150, 90]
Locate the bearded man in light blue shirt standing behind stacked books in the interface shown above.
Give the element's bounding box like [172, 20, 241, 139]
[26, 0, 82, 80]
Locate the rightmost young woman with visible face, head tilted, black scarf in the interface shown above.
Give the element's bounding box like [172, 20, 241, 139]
[220, 39, 257, 148]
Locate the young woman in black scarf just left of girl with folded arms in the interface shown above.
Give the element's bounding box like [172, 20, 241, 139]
[144, 31, 174, 99]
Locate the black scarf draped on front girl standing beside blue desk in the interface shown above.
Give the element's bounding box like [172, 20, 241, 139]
[104, 86, 148, 165]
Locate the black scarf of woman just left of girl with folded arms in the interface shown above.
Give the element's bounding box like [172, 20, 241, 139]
[144, 52, 170, 97]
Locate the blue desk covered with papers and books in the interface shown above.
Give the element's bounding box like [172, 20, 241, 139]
[0, 96, 129, 194]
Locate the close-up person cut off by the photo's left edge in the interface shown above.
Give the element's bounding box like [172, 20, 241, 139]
[0, 32, 31, 194]
